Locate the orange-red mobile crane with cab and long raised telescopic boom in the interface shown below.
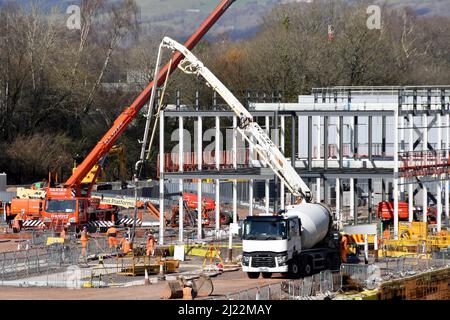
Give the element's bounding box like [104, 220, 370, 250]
[42, 0, 235, 230]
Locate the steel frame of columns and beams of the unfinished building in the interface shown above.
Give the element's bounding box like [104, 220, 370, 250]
[159, 86, 450, 241]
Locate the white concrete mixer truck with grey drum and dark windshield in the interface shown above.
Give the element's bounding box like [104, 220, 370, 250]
[242, 202, 341, 279]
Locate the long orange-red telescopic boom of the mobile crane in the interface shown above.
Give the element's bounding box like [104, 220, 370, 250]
[64, 0, 236, 192]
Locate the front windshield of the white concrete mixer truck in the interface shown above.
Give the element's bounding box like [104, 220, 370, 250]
[243, 221, 287, 240]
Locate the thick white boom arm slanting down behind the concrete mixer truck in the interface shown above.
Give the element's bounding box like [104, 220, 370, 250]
[162, 37, 312, 202]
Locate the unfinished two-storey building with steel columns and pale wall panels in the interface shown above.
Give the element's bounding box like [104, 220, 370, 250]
[159, 87, 450, 238]
